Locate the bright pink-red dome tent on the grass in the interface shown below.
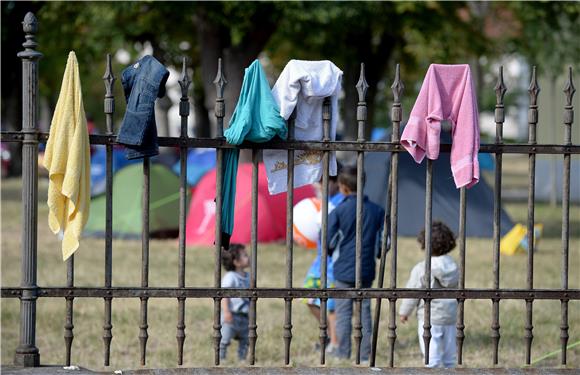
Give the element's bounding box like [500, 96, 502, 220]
[186, 163, 315, 246]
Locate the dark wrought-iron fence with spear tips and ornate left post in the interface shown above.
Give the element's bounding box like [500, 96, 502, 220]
[2, 13, 580, 367]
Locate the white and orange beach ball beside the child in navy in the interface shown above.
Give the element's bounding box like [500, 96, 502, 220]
[292, 198, 321, 249]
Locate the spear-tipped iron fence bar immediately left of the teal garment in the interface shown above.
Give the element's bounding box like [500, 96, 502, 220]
[213, 58, 228, 366]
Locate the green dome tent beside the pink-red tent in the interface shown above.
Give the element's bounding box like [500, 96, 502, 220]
[84, 163, 190, 238]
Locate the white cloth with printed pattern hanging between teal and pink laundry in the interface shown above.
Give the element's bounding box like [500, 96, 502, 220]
[264, 60, 342, 194]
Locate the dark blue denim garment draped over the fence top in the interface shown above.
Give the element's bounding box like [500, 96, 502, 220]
[117, 56, 169, 159]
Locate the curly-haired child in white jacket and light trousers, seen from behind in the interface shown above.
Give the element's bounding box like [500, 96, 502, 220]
[399, 221, 459, 368]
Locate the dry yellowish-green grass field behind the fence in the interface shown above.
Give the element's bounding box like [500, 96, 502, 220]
[1, 176, 580, 370]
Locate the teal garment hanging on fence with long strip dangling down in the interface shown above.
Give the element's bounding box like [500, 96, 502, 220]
[221, 60, 287, 249]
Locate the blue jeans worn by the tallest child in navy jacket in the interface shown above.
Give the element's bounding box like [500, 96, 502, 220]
[335, 280, 372, 361]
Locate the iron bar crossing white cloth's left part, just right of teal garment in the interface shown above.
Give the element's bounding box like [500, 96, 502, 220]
[284, 111, 296, 366]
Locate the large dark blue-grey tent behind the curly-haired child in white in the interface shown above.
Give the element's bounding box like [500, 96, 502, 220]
[364, 132, 514, 237]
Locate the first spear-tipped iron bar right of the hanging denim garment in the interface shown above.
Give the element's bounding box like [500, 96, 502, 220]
[175, 57, 191, 366]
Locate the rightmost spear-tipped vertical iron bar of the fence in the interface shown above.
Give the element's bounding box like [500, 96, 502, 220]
[560, 66, 576, 366]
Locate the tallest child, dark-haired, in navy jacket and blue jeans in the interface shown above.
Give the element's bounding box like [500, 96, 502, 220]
[328, 166, 385, 361]
